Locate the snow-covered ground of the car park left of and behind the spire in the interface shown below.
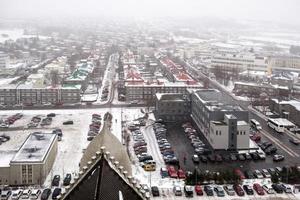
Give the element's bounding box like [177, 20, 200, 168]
[0, 108, 143, 186]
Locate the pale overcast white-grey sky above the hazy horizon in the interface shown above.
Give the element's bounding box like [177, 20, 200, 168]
[0, 0, 300, 24]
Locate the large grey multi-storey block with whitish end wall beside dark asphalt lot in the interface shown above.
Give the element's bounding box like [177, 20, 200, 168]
[189, 89, 250, 150]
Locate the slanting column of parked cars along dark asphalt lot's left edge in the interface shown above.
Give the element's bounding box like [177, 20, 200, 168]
[153, 122, 179, 166]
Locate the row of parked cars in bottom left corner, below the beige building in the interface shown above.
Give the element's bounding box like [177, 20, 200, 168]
[0, 187, 61, 200]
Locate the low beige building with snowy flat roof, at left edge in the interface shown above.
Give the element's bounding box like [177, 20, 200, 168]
[0, 133, 57, 185]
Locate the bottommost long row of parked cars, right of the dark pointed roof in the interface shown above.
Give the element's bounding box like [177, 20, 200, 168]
[170, 183, 292, 197]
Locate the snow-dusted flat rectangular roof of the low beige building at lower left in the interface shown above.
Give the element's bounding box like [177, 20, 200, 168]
[11, 133, 56, 162]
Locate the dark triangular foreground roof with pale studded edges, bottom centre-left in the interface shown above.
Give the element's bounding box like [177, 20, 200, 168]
[63, 155, 143, 200]
